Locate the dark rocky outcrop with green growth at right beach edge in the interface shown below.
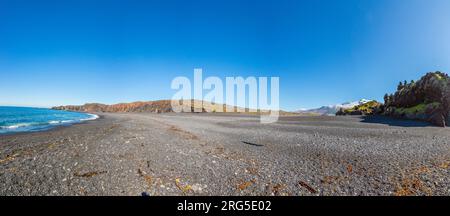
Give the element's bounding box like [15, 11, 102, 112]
[384, 72, 450, 127]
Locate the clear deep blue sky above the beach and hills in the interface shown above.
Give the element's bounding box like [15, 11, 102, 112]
[0, 0, 450, 110]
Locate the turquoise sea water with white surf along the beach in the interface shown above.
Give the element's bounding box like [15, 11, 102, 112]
[0, 106, 98, 134]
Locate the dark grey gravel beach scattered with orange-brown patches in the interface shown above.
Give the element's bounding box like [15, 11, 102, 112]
[0, 113, 450, 196]
